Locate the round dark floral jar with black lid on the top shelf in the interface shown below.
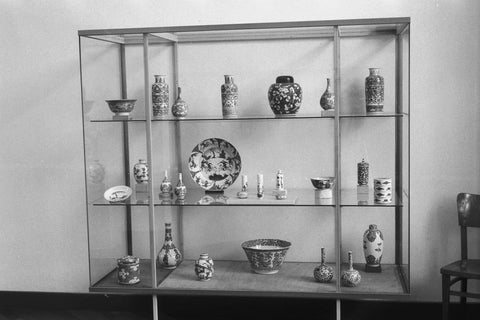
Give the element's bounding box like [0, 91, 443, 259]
[268, 76, 302, 116]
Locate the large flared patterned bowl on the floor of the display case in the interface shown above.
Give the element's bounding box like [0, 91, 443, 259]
[242, 239, 292, 274]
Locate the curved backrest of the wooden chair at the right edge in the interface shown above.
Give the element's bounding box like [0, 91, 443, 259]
[457, 192, 480, 260]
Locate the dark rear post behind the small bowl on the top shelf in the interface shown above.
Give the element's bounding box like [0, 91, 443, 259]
[120, 44, 133, 255]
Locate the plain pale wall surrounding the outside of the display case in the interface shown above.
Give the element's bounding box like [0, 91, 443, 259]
[0, 0, 480, 301]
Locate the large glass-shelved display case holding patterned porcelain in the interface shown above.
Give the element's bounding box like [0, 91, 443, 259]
[78, 18, 410, 317]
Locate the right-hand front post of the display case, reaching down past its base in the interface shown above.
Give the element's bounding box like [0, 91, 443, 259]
[333, 26, 342, 320]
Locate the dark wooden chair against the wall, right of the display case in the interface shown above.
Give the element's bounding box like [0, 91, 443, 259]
[440, 193, 480, 320]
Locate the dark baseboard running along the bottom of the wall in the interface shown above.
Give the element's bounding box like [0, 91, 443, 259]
[0, 292, 480, 320]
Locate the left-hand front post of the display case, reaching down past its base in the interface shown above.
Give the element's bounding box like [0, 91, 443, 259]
[143, 33, 158, 320]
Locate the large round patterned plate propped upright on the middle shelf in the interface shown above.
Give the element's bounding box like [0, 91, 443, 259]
[188, 138, 242, 191]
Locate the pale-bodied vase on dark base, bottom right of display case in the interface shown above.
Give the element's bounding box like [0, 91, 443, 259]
[363, 224, 383, 272]
